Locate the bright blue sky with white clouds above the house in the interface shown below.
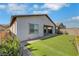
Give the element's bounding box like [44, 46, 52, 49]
[0, 3, 79, 28]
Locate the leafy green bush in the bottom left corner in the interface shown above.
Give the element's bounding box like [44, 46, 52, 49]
[0, 36, 20, 56]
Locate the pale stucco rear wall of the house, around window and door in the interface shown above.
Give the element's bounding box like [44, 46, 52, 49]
[14, 16, 55, 41]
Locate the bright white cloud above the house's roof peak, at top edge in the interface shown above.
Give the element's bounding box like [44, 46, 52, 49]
[42, 3, 69, 11]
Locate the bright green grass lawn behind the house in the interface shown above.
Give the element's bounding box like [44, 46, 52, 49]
[27, 35, 77, 56]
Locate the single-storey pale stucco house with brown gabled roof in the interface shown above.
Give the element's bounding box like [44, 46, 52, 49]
[10, 14, 56, 41]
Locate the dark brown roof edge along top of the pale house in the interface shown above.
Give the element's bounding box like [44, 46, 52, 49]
[10, 14, 56, 27]
